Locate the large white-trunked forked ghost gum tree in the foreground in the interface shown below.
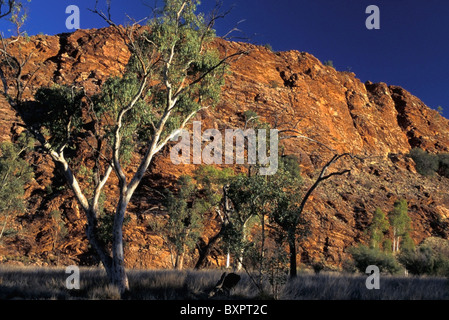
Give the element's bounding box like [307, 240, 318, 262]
[2, 0, 244, 293]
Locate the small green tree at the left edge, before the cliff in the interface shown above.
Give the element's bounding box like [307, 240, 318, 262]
[0, 135, 33, 239]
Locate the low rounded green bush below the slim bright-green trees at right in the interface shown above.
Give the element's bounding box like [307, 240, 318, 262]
[349, 245, 401, 274]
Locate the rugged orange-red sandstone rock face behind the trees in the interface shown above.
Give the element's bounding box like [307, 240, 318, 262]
[0, 28, 449, 268]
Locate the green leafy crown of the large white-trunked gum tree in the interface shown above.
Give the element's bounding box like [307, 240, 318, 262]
[35, 0, 226, 169]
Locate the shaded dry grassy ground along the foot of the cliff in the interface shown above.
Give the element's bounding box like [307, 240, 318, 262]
[0, 266, 449, 300]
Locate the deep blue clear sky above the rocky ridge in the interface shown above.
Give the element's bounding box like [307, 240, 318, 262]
[0, 0, 449, 118]
